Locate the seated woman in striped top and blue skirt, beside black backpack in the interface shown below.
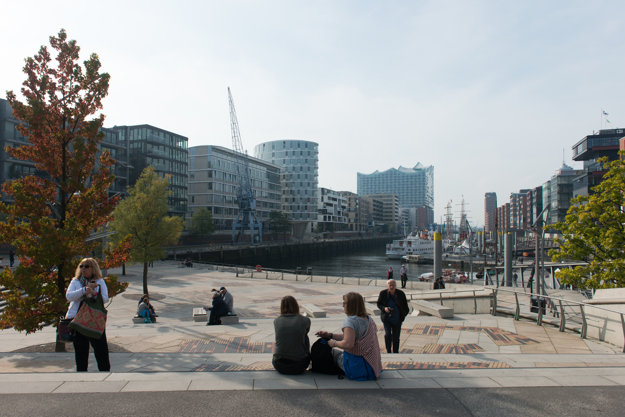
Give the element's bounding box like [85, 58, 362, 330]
[316, 292, 382, 381]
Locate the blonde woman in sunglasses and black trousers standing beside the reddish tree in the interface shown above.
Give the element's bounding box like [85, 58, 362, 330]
[65, 258, 111, 372]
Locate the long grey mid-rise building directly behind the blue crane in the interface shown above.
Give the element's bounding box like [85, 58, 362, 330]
[188, 145, 282, 232]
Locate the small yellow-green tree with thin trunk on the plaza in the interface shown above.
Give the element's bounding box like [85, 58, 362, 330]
[111, 166, 184, 294]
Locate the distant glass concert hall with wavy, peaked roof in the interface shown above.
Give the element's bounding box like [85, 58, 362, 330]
[357, 163, 434, 228]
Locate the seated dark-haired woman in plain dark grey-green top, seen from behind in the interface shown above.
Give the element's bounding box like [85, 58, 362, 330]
[271, 295, 310, 375]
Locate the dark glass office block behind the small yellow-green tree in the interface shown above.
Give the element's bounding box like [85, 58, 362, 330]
[111, 125, 189, 219]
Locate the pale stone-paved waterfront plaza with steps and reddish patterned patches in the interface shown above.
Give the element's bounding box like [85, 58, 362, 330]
[0, 262, 625, 415]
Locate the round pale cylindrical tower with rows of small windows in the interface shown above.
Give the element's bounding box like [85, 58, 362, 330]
[254, 139, 319, 232]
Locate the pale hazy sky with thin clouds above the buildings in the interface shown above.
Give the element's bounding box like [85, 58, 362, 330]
[0, 0, 625, 226]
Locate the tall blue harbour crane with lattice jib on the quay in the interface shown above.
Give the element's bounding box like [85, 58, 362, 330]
[228, 87, 263, 244]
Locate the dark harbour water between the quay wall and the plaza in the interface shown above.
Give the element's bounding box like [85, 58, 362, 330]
[272, 247, 433, 280]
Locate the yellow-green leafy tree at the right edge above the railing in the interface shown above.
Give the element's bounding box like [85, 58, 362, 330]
[548, 158, 625, 288]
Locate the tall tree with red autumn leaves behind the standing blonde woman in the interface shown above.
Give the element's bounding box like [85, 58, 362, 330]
[0, 30, 128, 333]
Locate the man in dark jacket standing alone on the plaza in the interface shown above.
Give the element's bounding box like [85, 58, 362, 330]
[378, 279, 410, 353]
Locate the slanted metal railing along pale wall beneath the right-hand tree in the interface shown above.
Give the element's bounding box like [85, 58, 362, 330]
[491, 287, 625, 353]
